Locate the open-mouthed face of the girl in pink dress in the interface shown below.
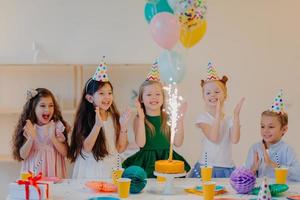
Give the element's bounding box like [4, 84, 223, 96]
[35, 96, 54, 125]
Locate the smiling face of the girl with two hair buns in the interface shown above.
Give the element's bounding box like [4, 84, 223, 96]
[203, 81, 226, 107]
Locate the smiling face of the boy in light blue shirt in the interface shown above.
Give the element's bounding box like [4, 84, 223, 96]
[260, 115, 287, 144]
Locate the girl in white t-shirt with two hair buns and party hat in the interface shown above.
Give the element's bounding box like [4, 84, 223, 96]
[190, 63, 244, 178]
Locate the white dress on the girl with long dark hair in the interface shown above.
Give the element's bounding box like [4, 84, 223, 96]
[72, 117, 117, 179]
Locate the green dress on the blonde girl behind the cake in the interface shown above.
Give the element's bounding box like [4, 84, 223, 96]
[123, 115, 191, 178]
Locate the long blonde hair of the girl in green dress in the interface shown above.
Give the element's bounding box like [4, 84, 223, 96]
[138, 80, 170, 138]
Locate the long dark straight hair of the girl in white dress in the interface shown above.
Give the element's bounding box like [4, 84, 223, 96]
[69, 79, 120, 162]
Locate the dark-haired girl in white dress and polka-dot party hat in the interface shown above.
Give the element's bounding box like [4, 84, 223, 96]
[69, 60, 130, 179]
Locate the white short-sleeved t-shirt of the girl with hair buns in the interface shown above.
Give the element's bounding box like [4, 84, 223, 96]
[196, 112, 234, 168]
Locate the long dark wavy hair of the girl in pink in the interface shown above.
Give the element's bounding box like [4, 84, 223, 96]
[12, 88, 70, 161]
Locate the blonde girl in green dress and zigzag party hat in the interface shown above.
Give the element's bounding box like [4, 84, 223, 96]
[123, 63, 190, 178]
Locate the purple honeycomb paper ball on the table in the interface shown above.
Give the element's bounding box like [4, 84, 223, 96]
[230, 167, 256, 194]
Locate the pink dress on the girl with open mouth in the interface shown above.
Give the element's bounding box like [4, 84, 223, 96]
[21, 121, 67, 178]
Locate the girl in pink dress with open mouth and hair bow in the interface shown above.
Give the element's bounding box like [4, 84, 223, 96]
[13, 88, 70, 178]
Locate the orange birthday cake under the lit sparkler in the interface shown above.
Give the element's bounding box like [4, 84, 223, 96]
[155, 160, 184, 174]
